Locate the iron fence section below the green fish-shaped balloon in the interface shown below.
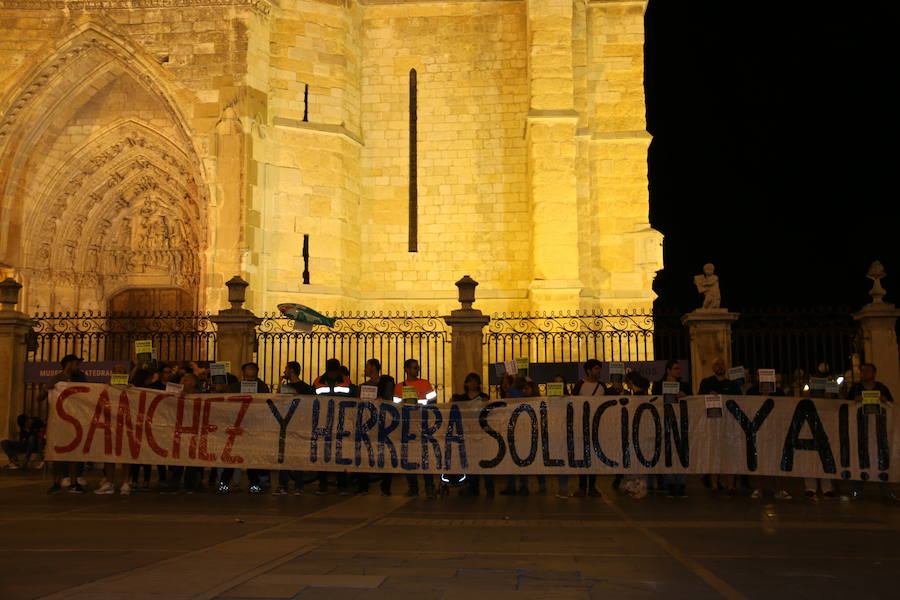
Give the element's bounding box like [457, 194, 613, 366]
[256, 312, 450, 400]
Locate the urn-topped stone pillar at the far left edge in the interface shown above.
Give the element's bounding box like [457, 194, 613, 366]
[0, 277, 31, 440]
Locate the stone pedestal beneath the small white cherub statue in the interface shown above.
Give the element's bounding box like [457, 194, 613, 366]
[681, 308, 740, 392]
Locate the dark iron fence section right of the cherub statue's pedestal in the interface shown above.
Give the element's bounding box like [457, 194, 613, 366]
[732, 307, 862, 392]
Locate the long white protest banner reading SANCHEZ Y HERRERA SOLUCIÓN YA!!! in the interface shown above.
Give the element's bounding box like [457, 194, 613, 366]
[47, 383, 900, 481]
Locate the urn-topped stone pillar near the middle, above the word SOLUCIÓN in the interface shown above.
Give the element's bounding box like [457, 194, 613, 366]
[444, 275, 491, 394]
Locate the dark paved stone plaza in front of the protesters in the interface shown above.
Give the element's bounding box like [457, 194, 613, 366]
[0, 472, 900, 600]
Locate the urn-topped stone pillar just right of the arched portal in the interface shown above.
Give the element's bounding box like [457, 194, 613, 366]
[209, 275, 262, 374]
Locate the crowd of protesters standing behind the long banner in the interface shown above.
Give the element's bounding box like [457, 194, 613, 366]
[2, 355, 896, 501]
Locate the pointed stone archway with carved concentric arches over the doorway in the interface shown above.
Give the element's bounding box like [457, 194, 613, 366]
[0, 17, 208, 310]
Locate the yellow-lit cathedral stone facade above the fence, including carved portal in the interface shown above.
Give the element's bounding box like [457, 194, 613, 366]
[0, 0, 662, 313]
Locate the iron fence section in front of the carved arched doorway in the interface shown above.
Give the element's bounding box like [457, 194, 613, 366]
[23, 312, 216, 418]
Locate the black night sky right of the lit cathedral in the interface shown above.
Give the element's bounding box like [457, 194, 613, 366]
[645, 0, 900, 310]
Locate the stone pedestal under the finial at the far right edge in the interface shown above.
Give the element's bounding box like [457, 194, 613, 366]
[853, 302, 900, 398]
